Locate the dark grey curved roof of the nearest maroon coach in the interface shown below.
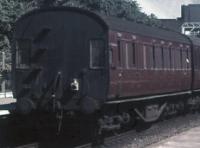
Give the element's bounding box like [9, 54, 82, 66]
[18, 7, 190, 44]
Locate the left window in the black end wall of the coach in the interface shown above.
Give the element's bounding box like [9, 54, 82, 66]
[16, 39, 31, 68]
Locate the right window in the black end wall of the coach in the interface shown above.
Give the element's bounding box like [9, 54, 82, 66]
[90, 39, 105, 69]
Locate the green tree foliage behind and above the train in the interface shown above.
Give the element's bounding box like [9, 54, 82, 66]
[0, 0, 160, 73]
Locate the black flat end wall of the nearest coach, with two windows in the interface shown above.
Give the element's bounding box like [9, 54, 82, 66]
[13, 8, 108, 112]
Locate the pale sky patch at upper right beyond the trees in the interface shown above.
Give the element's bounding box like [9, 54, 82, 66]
[137, 0, 200, 18]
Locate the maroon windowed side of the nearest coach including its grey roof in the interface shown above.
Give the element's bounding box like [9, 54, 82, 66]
[106, 18, 192, 98]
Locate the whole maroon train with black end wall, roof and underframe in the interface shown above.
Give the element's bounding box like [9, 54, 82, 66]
[12, 7, 200, 130]
